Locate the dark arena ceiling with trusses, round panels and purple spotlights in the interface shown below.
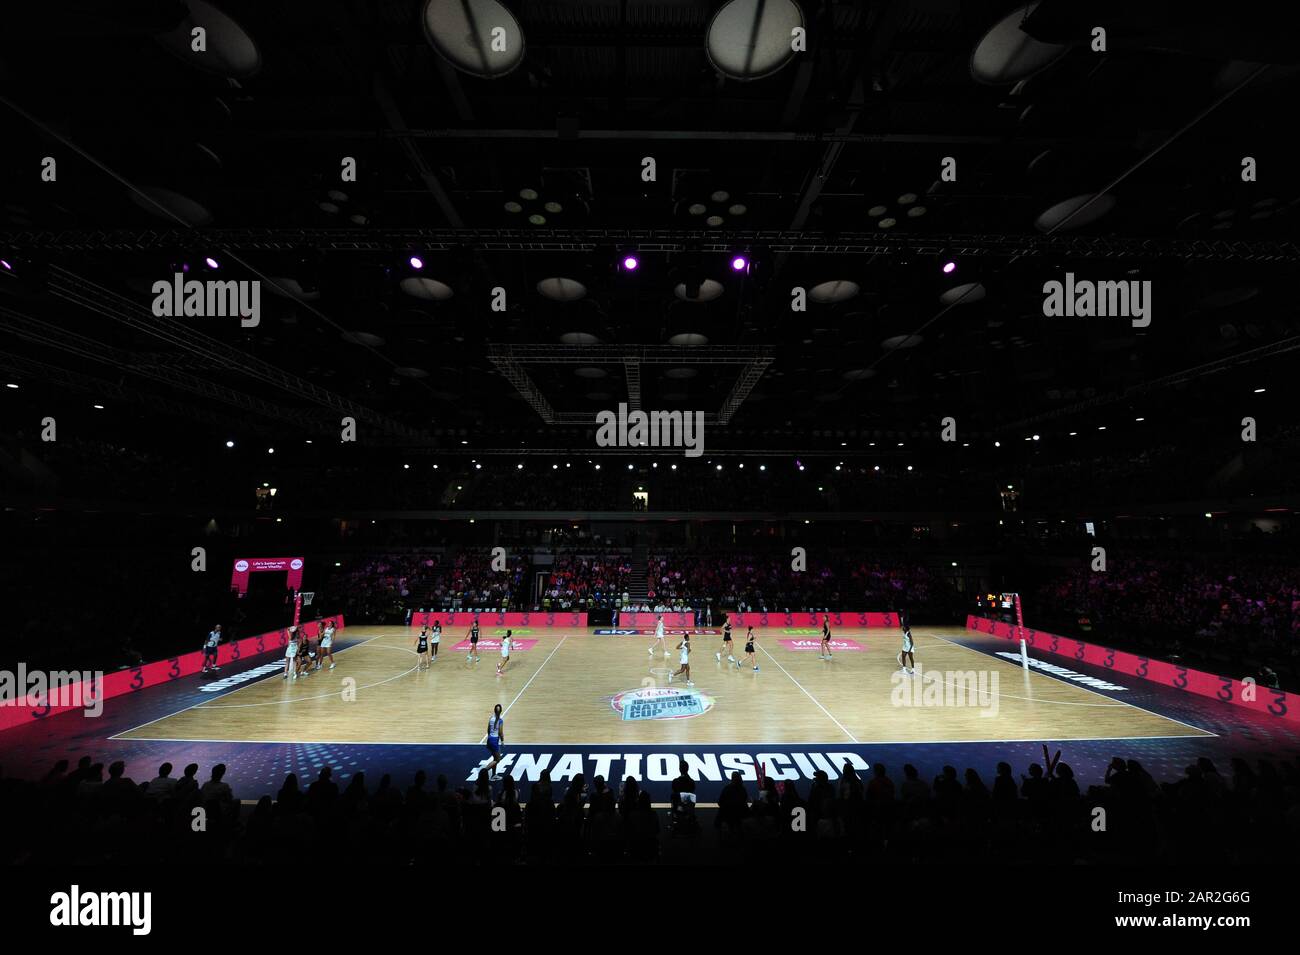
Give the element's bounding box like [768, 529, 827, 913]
[0, 0, 1300, 478]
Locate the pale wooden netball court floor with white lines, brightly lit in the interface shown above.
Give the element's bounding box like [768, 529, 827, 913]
[114, 626, 1213, 746]
